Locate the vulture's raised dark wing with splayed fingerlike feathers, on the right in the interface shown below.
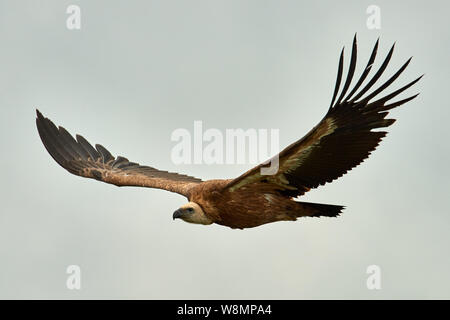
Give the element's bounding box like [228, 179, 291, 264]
[226, 35, 421, 197]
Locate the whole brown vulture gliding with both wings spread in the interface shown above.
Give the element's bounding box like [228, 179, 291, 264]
[36, 36, 421, 229]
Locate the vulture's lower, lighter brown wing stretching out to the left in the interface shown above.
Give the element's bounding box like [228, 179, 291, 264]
[36, 110, 201, 197]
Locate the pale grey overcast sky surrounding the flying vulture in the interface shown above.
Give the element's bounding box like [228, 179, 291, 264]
[0, 0, 450, 299]
